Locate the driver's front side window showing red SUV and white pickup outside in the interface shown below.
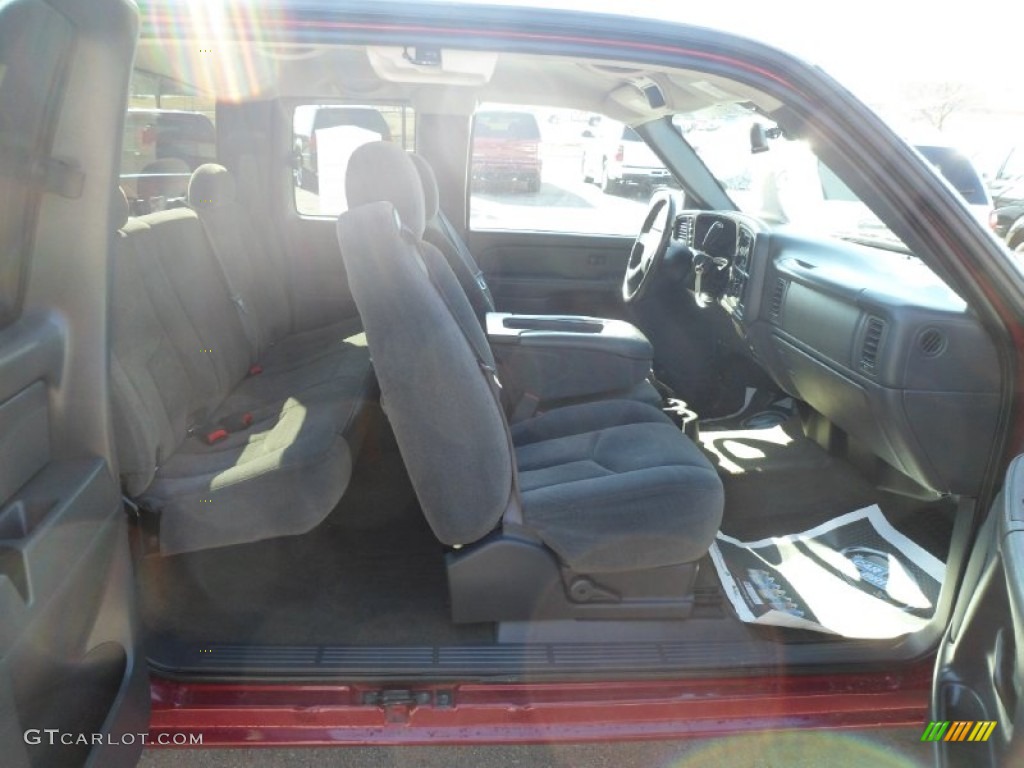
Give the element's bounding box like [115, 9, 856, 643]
[469, 104, 659, 237]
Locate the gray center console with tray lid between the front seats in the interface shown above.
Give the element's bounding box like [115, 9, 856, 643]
[487, 312, 653, 409]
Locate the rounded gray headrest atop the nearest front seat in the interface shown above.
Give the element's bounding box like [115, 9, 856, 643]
[345, 141, 426, 238]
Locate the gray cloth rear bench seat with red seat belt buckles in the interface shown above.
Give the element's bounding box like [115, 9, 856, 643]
[111, 183, 376, 554]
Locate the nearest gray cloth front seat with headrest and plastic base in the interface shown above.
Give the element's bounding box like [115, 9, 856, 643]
[337, 142, 724, 622]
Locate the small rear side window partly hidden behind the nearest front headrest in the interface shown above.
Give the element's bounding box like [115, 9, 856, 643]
[292, 103, 416, 216]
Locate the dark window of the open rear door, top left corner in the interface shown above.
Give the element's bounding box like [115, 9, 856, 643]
[0, 3, 73, 328]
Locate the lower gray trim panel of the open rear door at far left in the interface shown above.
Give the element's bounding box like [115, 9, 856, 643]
[0, 317, 148, 766]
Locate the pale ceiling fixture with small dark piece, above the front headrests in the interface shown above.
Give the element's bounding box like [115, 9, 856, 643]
[367, 45, 498, 85]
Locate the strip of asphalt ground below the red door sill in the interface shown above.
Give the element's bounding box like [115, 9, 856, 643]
[139, 728, 933, 768]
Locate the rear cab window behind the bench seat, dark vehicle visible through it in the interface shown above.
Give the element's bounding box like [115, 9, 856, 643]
[121, 70, 217, 215]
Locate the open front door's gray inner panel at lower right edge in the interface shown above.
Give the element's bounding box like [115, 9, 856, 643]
[931, 456, 1024, 768]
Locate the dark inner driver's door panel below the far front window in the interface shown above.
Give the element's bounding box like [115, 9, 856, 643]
[469, 231, 632, 317]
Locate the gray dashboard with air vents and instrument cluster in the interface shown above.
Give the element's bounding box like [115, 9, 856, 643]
[672, 211, 999, 495]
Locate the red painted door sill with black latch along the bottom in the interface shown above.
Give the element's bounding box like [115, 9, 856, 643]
[150, 663, 932, 746]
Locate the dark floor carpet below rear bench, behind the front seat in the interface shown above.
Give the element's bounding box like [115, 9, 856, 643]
[139, 434, 494, 645]
